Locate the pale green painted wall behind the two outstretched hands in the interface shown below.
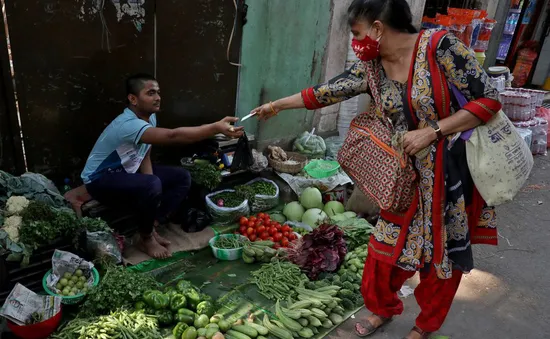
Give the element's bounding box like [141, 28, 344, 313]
[237, 0, 332, 148]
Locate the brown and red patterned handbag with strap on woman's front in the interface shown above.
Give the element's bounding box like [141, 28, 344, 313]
[338, 62, 417, 212]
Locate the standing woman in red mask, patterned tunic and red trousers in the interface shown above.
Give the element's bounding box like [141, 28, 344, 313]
[253, 0, 501, 339]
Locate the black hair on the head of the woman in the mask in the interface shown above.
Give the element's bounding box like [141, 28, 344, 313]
[348, 0, 418, 33]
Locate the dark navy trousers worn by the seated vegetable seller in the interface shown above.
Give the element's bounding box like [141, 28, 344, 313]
[86, 166, 191, 235]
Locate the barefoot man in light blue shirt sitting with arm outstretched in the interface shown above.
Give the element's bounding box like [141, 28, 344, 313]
[82, 74, 243, 258]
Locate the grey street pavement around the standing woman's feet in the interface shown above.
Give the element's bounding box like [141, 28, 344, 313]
[327, 157, 550, 339]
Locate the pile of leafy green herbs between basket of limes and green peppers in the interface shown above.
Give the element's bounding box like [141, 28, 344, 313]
[81, 266, 162, 317]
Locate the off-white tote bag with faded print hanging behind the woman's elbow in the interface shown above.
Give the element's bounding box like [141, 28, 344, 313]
[466, 110, 534, 206]
